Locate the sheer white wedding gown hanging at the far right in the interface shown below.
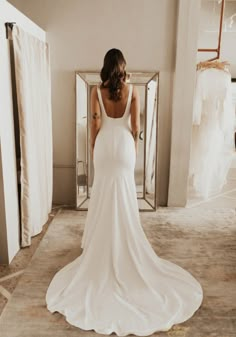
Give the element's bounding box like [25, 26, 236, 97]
[190, 68, 235, 198]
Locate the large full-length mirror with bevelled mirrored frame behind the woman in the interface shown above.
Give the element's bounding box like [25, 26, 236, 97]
[76, 71, 159, 211]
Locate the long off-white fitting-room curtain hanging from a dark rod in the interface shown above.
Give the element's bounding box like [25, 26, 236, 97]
[12, 26, 52, 247]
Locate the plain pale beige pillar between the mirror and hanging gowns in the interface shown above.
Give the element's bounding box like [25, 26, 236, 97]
[168, 0, 201, 207]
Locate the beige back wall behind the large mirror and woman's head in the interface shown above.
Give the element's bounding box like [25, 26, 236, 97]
[6, 0, 178, 205]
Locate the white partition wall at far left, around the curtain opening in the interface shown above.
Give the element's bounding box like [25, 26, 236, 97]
[0, 0, 46, 264]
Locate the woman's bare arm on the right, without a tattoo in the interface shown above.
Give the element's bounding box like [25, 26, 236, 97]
[130, 86, 140, 155]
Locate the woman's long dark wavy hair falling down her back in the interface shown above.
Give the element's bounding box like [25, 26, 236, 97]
[100, 48, 126, 101]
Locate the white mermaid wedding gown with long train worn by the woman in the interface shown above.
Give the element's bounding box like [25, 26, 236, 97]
[46, 85, 203, 336]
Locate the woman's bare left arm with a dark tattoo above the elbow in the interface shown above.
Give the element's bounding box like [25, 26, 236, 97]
[90, 86, 101, 156]
